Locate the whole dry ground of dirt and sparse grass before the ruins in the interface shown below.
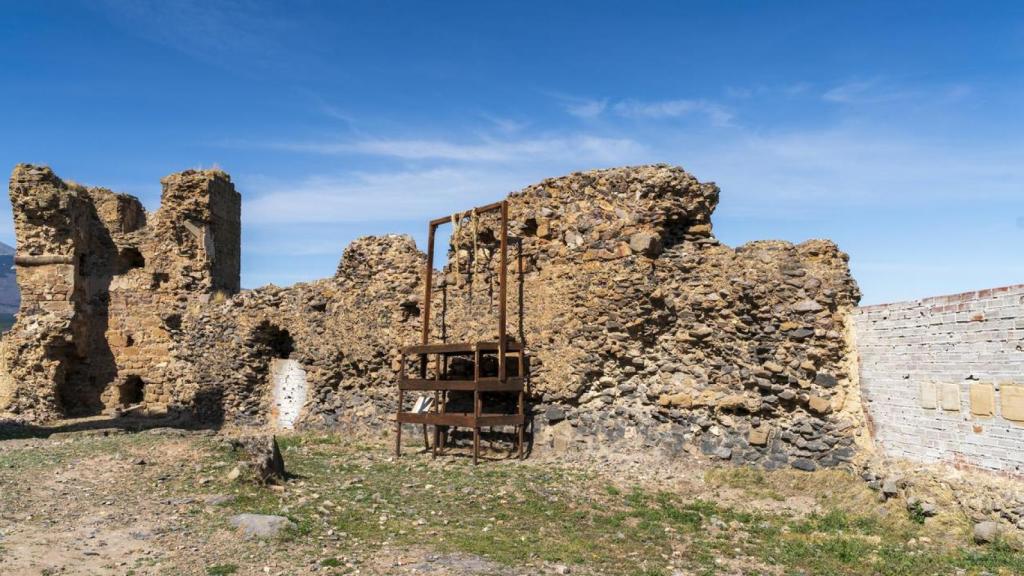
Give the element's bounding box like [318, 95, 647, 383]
[0, 416, 1024, 576]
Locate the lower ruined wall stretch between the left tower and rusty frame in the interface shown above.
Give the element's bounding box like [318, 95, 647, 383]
[175, 236, 425, 426]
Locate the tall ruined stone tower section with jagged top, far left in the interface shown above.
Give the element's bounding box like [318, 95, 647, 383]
[0, 165, 241, 418]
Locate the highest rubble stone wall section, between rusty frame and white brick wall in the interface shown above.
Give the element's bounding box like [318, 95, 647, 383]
[423, 166, 863, 468]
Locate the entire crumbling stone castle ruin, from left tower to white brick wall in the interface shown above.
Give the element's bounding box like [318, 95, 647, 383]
[0, 165, 865, 469]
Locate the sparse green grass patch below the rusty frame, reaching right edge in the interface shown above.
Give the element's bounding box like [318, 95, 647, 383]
[190, 436, 1021, 576]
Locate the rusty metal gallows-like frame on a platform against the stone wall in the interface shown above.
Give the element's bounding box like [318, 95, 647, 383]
[394, 201, 526, 464]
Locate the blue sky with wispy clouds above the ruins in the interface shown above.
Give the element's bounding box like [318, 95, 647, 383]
[0, 0, 1024, 303]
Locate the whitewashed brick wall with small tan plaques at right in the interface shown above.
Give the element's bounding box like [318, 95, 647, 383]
[854, 285, 1024, 474]
